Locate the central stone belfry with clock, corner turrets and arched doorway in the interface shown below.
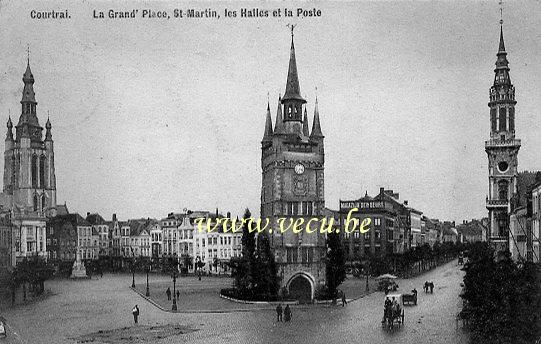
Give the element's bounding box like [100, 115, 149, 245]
[261, 30, 326, 301]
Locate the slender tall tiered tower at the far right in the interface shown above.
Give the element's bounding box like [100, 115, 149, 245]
[485, 26, 520, 251]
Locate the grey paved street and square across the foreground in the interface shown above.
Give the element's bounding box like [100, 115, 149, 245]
[0, 261, 467, 344]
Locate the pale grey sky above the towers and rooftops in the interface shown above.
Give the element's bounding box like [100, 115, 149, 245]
[0, 0, 541, 221]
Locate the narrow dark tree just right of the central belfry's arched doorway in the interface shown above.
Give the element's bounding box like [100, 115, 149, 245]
[326, 232, 346, 299]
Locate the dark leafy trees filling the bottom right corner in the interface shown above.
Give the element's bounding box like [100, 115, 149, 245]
[463, 243, 541, 344]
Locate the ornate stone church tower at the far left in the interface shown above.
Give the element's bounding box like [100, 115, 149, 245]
[2, 60, 56, 264]
